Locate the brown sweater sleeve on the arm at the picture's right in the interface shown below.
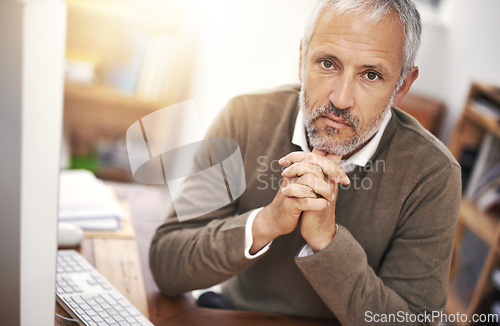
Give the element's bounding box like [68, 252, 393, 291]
[295, 164, 461, 325]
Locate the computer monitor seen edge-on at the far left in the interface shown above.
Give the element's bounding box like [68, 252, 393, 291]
[0, 0, 66, 325]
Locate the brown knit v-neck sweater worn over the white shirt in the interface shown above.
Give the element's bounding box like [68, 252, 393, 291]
[150, 86, 461, 325]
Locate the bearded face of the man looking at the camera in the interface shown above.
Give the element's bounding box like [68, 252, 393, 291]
[301, 9, 404, 155]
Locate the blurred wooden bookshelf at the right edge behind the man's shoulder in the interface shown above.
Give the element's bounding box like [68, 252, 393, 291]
[445, 83, 500, 325]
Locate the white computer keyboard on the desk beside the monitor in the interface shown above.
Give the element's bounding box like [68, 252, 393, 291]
[56, 250, 153, 326]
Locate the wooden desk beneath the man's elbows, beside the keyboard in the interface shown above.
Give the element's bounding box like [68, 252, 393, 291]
[59, 183, 335, 326]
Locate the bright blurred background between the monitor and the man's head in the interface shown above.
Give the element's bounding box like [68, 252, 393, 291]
[65, 0, 314, 179]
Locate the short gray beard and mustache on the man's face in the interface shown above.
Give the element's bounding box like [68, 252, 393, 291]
[299, 86, 396, 156]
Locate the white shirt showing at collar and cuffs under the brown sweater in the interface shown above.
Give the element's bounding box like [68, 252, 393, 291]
[245, 110, 392, 259]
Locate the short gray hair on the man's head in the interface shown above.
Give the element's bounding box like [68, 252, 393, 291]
[302, 0, 422, 88]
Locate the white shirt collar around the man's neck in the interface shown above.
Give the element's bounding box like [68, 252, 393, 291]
[292, 110, 392, 172]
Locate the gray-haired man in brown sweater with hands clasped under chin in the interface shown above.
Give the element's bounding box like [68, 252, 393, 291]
[150, 0, 460, 325]
